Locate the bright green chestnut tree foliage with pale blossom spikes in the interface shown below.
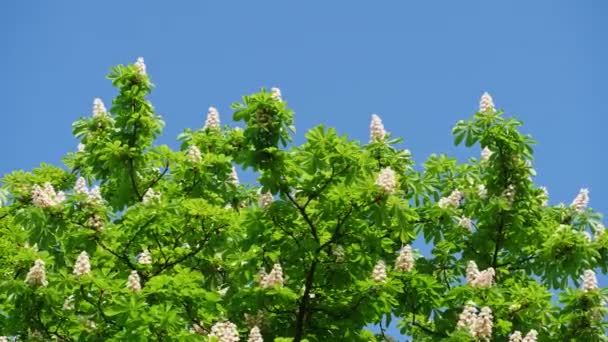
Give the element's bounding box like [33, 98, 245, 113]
[0, 60, 608, 342]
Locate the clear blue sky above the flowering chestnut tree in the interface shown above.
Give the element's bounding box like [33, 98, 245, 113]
[0, 0, 608, 340]
